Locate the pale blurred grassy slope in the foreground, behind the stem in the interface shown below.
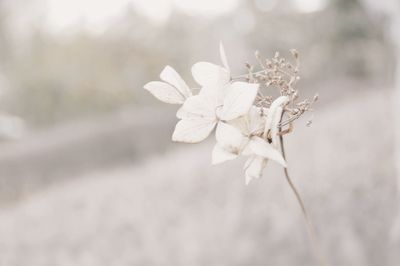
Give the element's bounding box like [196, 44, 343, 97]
[0, 91, 400, 266]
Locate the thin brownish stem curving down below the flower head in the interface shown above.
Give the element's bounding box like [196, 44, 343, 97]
[279, 122, 328, 266]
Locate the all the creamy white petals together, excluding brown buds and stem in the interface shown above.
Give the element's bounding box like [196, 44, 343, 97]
[144, 43, 300, 184]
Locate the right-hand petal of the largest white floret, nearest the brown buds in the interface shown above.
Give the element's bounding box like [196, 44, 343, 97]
[220, 81, 259, 121]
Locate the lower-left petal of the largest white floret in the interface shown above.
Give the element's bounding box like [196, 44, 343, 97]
[172, 119, 216, 143]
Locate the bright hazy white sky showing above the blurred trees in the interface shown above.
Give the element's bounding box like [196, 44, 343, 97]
[45, 0, 328, 33]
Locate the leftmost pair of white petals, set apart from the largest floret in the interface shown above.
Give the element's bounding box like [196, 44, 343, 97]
[144, 66, 192, 104]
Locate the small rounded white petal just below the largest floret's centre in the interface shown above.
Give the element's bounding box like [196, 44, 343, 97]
[215, 122, 246, 149]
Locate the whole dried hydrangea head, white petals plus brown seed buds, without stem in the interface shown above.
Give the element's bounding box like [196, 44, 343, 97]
[144, 44, 317, 184]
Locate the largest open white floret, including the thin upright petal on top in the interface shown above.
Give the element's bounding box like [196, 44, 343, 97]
[172, 44, 259, 143]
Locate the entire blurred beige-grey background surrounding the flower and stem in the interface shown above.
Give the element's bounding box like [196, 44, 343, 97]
[0, 0, 400, 266]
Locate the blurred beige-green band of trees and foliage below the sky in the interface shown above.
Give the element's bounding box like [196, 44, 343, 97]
[0, 0, 391, 126]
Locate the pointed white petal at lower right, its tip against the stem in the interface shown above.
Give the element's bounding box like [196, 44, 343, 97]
[248, 137, 286, 167]
